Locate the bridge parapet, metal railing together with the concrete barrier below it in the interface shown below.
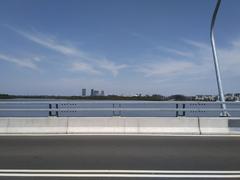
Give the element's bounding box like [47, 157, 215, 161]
[0, 101, 240, 134]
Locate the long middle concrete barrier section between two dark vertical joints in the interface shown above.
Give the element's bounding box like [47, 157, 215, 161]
[60, 117, 199, 134]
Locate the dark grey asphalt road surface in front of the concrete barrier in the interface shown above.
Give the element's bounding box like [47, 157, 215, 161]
[0, 136, 240, 180]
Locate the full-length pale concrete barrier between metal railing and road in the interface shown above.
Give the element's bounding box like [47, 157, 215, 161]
[0, 117, 240, 135]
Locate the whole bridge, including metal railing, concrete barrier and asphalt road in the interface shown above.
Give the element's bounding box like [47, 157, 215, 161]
[0, 100, 240, 180]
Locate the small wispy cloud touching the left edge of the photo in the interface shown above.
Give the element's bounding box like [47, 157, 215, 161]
[0, 53, 40, 70]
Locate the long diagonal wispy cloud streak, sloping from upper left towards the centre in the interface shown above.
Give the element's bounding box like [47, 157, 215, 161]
[8, 27, 127, 76]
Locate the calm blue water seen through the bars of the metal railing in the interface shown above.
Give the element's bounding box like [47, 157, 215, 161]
[0, 100, 240, 117]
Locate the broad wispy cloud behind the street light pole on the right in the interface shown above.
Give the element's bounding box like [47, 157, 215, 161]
[138, 39, 240, 81]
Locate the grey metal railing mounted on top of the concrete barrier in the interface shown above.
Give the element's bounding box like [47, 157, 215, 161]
[0, 101, 240, 116]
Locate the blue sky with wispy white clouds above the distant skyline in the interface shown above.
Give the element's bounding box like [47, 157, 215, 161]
[0, 0, 240, 95]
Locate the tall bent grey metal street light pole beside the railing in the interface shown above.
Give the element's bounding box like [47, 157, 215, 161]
[210, 0, 229, 116]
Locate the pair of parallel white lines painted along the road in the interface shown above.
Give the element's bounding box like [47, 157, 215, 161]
[0, 169, 240, 179]
